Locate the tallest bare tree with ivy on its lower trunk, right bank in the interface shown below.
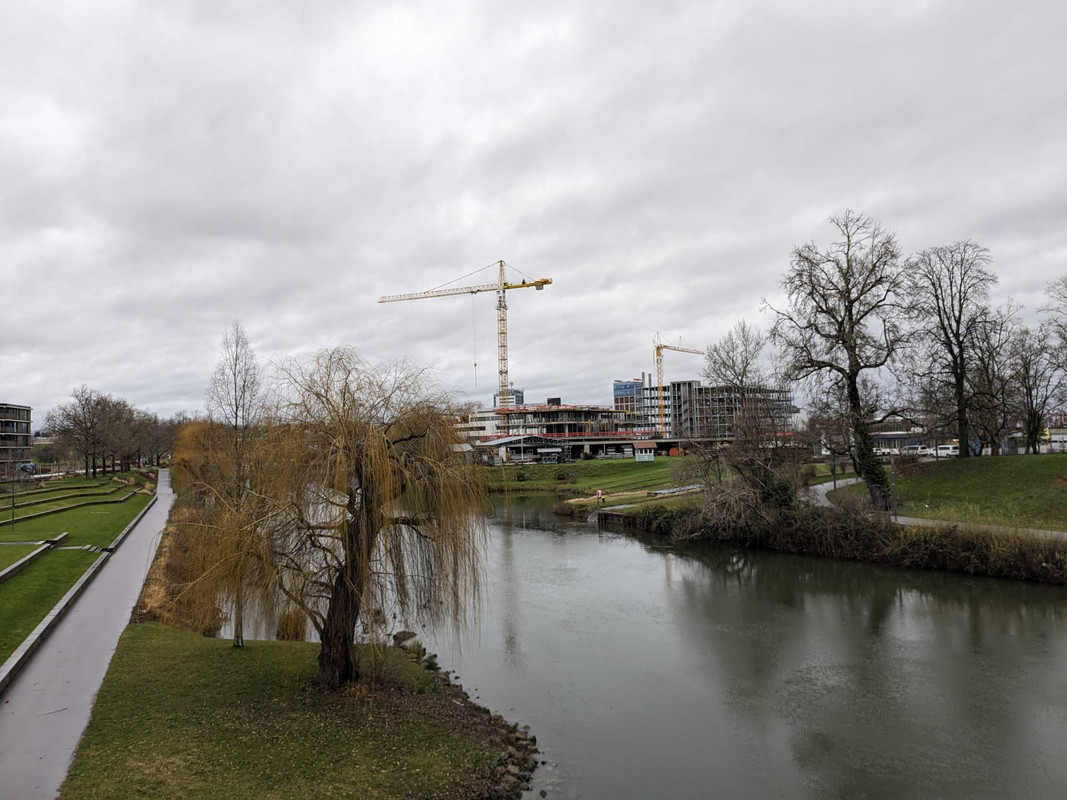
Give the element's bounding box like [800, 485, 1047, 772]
[765, 211, 905, 509]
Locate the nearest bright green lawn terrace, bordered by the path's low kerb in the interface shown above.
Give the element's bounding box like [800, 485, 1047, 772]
[0, 548, 100, 663]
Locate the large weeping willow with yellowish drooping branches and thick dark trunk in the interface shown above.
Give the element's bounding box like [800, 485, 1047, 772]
[262, 348, 485, 689]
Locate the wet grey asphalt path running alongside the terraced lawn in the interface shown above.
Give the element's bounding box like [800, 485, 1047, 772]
[0, 469, 174, 800]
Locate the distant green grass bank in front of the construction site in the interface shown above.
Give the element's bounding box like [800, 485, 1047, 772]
[484, 458, 680, 495]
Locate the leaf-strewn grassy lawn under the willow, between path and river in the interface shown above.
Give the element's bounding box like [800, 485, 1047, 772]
[61, 624, 499, 800]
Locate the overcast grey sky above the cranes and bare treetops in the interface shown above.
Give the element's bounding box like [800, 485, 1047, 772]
[0, 0, 1067, 427]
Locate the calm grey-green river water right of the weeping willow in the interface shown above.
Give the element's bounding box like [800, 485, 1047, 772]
[422, 498, 1067, 800]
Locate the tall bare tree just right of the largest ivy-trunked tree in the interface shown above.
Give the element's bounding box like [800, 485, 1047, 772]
[908, 241, 997, 458]
